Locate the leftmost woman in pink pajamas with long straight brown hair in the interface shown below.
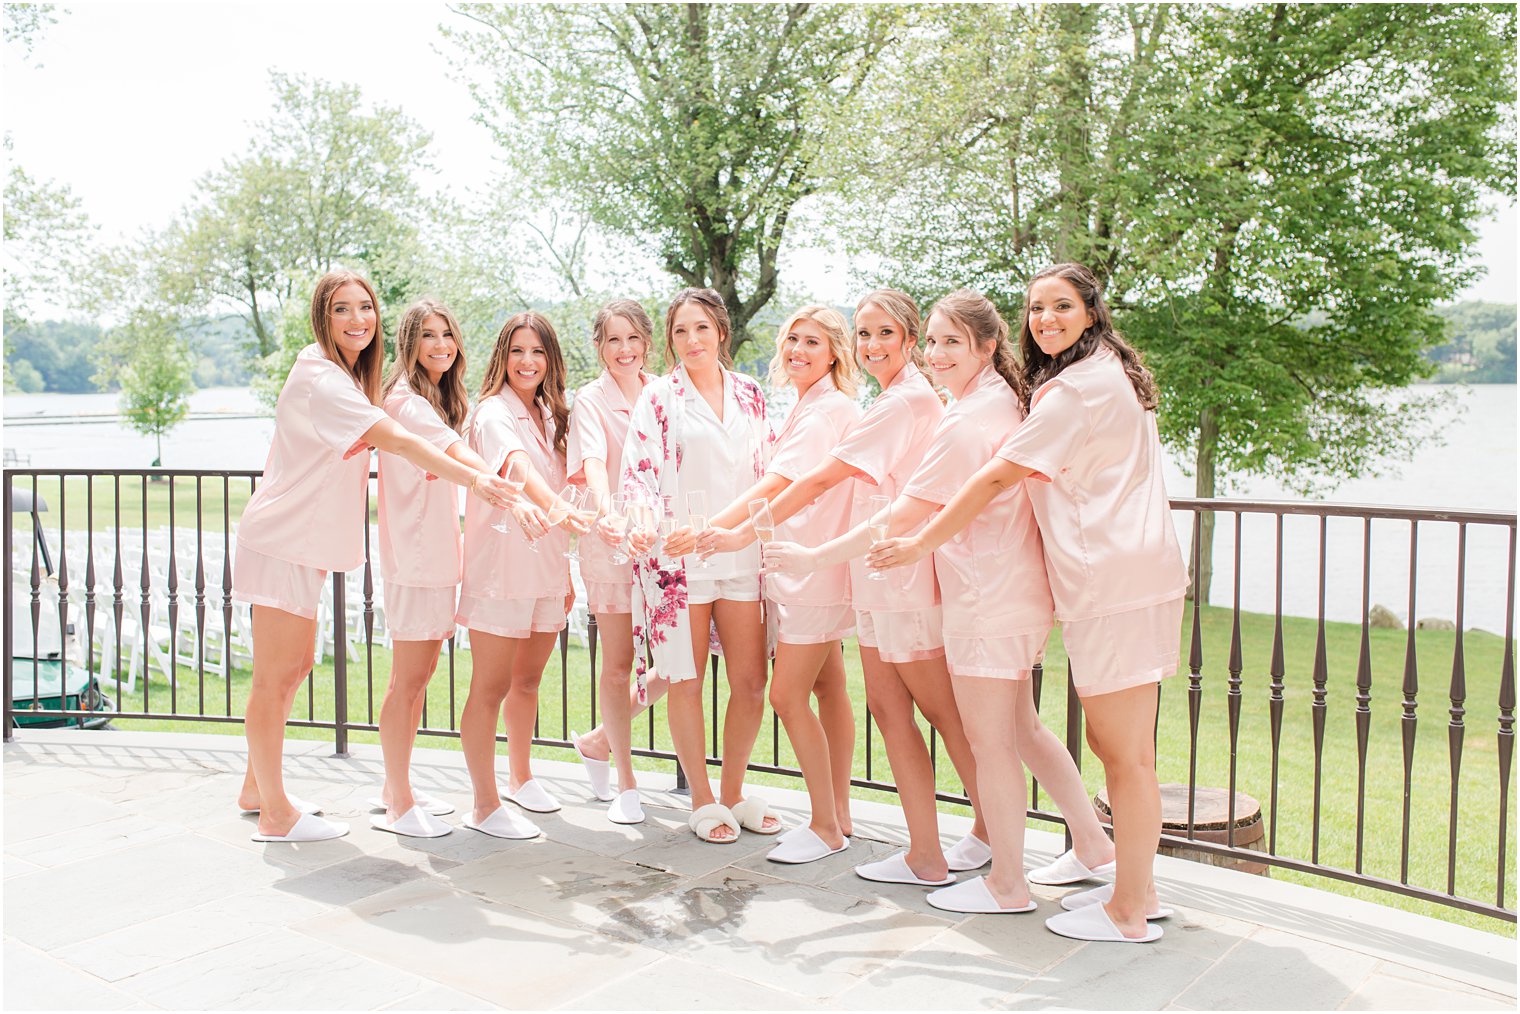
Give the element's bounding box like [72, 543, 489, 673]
[233, 271, 511, 842]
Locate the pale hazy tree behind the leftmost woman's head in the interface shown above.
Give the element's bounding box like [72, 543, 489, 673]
[157, 73, 430, 369]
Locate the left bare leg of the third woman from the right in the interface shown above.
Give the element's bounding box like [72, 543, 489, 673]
[860, 645, 950, 880]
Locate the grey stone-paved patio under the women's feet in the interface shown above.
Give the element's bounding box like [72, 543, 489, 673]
[3, 730, 1515, 1009]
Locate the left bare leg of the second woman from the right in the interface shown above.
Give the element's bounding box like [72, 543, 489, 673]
[953, 677, 1029, 908]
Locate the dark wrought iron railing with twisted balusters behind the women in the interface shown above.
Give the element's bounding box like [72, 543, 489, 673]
[3, 468, 1515, 923]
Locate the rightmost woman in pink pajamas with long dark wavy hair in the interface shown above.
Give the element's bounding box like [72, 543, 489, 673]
[871, 265, 1187, 943]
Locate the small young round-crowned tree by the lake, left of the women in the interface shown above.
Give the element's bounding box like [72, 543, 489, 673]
[96, 309, 195, 468]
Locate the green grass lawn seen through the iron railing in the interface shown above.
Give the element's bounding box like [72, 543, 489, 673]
[65, 607, 1515, 935]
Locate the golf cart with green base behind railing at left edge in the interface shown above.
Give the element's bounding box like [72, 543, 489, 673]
[8, 488, 116, 728]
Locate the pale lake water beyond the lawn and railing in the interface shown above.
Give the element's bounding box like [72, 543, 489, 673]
[5, 385, 1515, 632]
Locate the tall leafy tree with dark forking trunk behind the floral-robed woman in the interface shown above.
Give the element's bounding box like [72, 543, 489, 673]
[445, 3, 895, 348]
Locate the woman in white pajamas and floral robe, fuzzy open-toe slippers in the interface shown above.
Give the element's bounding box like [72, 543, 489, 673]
[623, 289, 781, 844]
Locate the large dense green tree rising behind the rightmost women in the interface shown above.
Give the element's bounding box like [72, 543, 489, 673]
[853, 5, 1515, 600]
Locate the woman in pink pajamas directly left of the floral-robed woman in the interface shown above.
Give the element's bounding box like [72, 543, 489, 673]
[565, 299, 666, 824]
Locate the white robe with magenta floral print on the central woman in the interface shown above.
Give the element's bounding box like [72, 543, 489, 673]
[622, 366, 772, 690]
